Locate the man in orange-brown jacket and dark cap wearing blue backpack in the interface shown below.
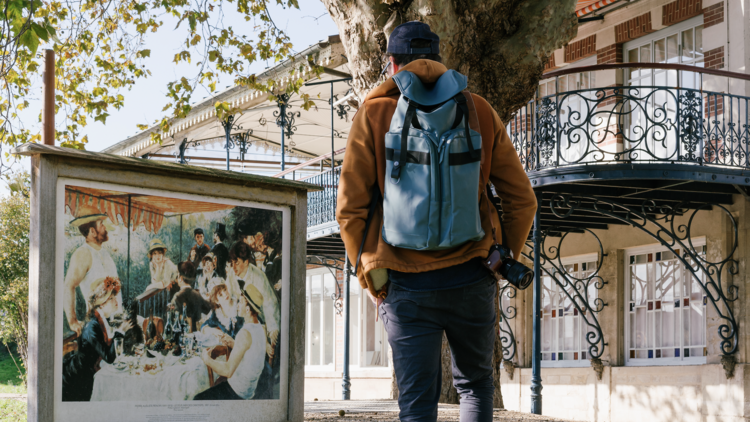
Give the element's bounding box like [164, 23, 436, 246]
[336, 22, 537, 422]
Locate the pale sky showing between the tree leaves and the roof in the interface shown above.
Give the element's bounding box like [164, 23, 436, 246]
[5, 0, 338, 188]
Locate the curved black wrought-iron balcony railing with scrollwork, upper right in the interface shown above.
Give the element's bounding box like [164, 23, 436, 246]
[507, 63, 750, 172]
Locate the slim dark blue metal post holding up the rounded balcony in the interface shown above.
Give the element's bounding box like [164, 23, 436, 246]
[531, 191, 543, 415]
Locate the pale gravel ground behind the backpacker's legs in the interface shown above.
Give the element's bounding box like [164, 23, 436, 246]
[305, 400, 571, 422]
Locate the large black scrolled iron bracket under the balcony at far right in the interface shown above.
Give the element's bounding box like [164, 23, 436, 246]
[550, 194, 739, 356]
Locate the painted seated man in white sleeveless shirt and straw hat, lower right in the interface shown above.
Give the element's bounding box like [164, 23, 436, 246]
[195, 284, 267, 400]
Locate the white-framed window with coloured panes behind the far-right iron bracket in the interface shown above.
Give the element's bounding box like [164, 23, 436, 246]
[625, 239, 706, 366]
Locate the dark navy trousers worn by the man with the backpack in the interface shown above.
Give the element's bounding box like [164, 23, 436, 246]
[380, 277, 497, 422]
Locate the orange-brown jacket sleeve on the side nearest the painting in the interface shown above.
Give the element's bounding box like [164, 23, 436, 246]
[336, 104, 379, 265]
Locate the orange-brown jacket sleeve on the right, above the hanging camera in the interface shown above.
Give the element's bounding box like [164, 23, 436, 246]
[490, 105, 537, 259]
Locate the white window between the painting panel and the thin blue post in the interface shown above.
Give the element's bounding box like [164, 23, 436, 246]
[305, 268, 336, 368]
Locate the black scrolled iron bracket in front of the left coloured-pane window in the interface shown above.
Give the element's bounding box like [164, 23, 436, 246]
[523, 227, 608, 359]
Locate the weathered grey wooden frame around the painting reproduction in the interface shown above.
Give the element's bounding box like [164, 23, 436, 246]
[19, 144, 319, 422]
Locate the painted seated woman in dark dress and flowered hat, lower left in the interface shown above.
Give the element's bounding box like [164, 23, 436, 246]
[62, 277, 133, 401]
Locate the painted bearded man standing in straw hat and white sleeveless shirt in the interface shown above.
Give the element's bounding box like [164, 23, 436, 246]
[63, 203, 122, 335]
